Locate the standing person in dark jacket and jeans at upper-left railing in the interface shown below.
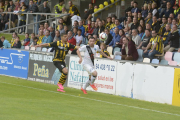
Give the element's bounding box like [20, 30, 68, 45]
[28, 0, 39, 34]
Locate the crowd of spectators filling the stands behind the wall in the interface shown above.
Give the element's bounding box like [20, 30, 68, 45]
[0, 0, 180, 61]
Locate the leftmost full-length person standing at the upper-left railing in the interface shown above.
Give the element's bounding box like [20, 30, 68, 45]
[17, 5, 27, 34]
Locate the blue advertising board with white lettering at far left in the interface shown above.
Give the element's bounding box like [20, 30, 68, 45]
[0, 49, 29, 79]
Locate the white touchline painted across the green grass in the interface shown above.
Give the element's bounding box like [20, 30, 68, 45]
[0, 82, 180, 117]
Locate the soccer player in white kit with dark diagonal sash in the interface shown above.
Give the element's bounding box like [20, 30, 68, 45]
[77, 37, 112, 94]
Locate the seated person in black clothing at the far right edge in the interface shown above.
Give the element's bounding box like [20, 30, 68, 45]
[164, 25, 179, 52]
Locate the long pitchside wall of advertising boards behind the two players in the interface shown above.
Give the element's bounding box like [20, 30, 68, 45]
[0, 49, 180, 106]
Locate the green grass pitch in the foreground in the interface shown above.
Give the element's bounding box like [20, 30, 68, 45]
[0, 76, 180, 120]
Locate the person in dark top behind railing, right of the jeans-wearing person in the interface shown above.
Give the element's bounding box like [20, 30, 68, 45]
[39, 1, 51, 21]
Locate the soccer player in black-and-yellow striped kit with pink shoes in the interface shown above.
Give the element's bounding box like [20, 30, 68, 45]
[36, 33, 79, 92]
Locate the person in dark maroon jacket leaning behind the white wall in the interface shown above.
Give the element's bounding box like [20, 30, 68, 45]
[122, 37, 139, 61]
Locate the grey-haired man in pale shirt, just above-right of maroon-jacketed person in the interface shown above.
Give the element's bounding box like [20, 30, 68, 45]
[132, 29, 141, 46]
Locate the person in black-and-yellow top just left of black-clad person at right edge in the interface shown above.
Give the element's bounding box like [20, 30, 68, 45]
[162, 24, 171, 47]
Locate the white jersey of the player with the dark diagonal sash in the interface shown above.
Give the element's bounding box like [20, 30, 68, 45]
[79, 45, 101, 67]
